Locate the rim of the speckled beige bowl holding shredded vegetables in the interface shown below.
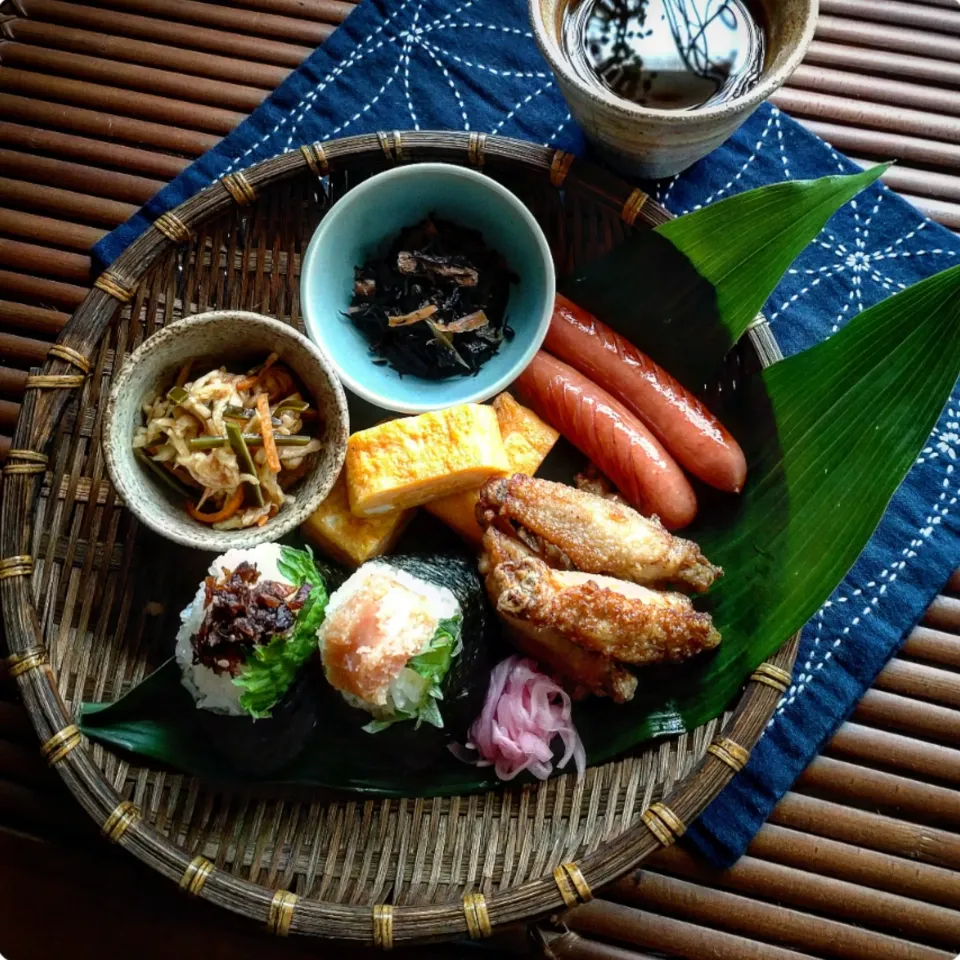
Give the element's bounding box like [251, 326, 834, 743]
[102, 310, 350, 553]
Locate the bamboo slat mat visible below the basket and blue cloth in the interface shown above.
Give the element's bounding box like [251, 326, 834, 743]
[0, 571, 960, 960]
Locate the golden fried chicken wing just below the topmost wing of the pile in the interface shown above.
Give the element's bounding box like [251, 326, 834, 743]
[487, 557, 720, 664]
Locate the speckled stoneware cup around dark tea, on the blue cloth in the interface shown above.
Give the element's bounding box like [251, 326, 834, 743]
[530, 0, 819, 180]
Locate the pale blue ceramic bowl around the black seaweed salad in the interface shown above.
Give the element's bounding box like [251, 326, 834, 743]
[300, 163, 555, 413]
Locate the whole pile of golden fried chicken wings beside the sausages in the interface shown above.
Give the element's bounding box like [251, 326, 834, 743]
[477, 484, 721, 702]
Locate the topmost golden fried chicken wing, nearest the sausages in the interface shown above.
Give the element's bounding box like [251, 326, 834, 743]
[477, 474, 722, 591]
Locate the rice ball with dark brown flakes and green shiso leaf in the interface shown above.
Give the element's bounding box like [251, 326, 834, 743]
[176, 543, 328, 719]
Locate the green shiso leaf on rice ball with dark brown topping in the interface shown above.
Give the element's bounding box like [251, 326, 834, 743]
[233, 546, 328, 719]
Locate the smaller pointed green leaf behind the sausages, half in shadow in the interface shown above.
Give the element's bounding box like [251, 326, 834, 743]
[561, 166, 886, 390]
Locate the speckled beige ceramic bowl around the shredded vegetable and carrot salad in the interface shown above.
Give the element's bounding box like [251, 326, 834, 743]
[103, 310, 350, 553]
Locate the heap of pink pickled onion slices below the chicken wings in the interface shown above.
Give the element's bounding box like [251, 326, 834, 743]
[451, 656, 586, 780]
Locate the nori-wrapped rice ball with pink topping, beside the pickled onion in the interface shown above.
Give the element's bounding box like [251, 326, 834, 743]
[317, 554, 488, 741]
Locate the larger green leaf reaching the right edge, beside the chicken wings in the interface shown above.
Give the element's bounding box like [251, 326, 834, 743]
[581, 258, 960, 762]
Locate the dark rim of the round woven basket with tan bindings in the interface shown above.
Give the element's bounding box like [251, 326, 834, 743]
[0, 131, 799, 948]
